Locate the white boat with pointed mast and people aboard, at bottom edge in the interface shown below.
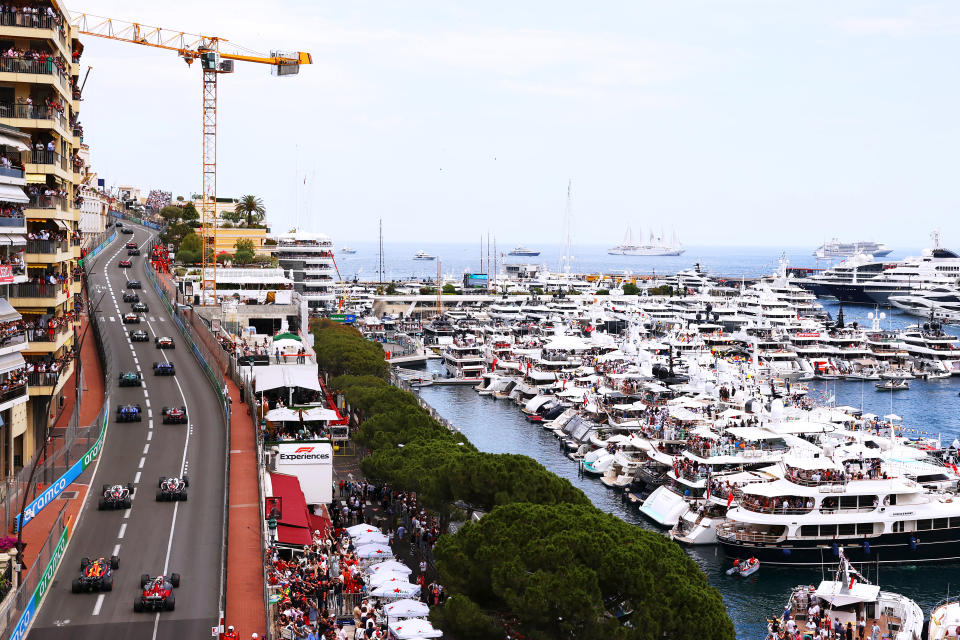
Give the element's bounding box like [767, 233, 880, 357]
[771, 550, 928, 640]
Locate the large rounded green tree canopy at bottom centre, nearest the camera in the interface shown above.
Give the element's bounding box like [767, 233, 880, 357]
[432, 503, 734, 640]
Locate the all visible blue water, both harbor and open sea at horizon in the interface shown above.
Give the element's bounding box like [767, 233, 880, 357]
[376, 243, 960, 640]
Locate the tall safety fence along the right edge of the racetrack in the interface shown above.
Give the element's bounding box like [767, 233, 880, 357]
[142, 258, 231, 628]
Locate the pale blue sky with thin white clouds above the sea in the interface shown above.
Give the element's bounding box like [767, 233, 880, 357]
[71, 0, 960, 248]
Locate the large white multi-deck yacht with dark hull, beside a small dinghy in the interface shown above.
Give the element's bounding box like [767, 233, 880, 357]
[717, 450, 960, 566]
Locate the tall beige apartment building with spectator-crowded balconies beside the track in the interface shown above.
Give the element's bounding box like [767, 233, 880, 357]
[0, 1, 85, 474]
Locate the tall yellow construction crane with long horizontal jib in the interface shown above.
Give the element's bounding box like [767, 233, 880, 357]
[71, 13, 313, 305]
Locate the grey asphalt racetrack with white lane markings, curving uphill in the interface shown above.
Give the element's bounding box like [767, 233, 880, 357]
[28, 223, 225, 640]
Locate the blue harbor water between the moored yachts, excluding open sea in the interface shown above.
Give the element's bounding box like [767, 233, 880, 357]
[419, 303, 960, 640]
